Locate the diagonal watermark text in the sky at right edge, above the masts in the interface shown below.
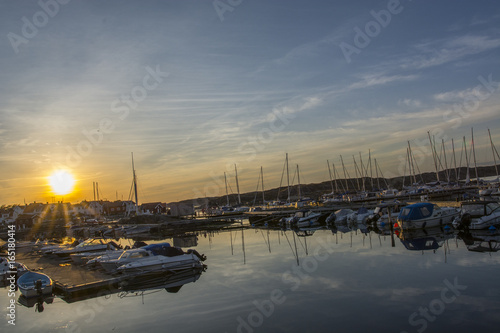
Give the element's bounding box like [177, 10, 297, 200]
[443, 74, 500, 129]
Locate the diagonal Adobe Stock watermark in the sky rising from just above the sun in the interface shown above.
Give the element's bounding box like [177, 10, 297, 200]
[59, 65, 169, 168]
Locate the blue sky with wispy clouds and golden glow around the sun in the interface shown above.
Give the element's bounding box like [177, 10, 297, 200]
[0, 0, 500, 205]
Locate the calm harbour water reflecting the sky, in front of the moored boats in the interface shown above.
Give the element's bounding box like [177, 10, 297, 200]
[0, 229, 500, 332]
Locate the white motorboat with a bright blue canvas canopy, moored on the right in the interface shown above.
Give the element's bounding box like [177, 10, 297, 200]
[398, 202, 459, 229]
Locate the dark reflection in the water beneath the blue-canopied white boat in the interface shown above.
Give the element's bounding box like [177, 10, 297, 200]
[398, 227, 455, 251]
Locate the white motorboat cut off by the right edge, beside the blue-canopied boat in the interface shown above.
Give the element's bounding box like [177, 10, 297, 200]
[453, 201, 500, 229]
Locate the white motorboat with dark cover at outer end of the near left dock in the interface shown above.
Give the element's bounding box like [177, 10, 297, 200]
[117, 245, 206, 273]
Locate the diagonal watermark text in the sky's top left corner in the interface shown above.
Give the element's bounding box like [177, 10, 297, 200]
[7, 0, 71, 54]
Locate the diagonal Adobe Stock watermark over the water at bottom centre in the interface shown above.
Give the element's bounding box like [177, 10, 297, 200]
[229, 237, 335, 333]
